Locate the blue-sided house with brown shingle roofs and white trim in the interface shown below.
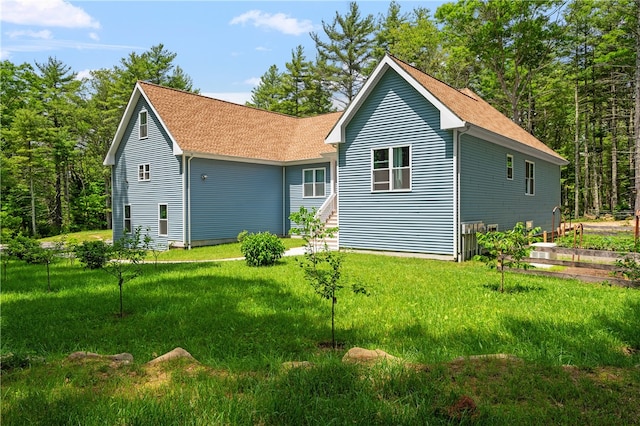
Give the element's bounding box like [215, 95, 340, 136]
[104, 56, 567, 260]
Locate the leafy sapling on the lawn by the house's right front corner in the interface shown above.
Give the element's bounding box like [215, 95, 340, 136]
[476, 222, 540, 293]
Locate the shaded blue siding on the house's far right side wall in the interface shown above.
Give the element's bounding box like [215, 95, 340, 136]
[459, 135, 560, 231]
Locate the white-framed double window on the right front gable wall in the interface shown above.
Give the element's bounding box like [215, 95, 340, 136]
[371, 146, 411, 191]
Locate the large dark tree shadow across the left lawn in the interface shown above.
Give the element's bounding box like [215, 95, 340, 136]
[2, 263, 330, 369]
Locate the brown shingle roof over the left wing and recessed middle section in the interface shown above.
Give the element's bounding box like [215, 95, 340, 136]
[138, 82, 341, 162]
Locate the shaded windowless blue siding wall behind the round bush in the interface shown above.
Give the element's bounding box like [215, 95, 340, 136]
[190, 158, 284, 242]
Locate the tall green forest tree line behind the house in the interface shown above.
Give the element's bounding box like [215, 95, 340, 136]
[0, 0, 640, 240]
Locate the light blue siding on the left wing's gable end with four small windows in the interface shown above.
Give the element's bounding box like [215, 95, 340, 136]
[112, 98, 183, 248]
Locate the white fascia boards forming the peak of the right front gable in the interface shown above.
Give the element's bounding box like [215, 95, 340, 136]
[324, 55, 466, 144]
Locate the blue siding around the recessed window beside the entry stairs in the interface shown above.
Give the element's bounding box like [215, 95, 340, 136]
[285, 163, 331, 232]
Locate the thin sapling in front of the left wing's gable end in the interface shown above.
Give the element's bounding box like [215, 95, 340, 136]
[102, 226, 146, 318]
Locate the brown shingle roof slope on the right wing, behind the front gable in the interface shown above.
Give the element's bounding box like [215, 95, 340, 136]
[389, 56, 565, 161]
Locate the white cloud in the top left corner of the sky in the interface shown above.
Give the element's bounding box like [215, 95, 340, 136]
[0, 0, 100, 29]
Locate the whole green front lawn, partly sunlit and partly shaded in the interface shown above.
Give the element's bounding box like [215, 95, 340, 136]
[0, 250, 640, 425]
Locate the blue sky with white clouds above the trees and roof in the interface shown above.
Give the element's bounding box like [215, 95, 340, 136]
[0, 0, 443, 103]
